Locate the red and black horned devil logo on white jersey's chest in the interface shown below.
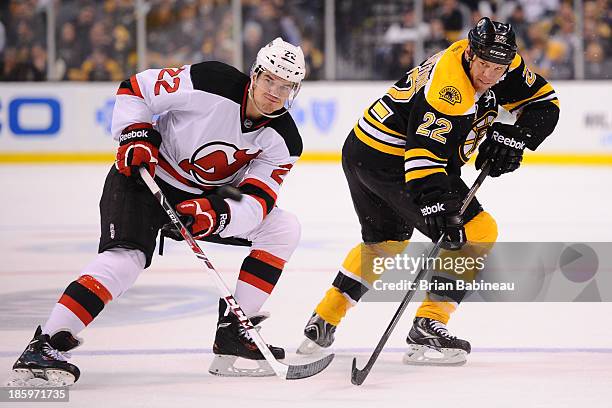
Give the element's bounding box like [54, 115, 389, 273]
[179, 141, 261, 185]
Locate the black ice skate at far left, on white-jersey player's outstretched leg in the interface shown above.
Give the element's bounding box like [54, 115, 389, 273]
[7, 326, 82, 387]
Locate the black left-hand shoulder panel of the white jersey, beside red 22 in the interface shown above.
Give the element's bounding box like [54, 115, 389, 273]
[190, 61, 249, 105]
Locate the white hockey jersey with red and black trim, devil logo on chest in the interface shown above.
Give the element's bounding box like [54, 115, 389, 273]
[112, 62, 302, 237]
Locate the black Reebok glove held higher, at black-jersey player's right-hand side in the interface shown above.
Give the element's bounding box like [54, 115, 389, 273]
[476, 122, 530, 177]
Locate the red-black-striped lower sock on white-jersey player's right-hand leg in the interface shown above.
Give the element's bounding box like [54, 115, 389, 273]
[234, 249, 285, 316]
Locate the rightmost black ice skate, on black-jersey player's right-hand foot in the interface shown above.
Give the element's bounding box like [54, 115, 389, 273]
[403, 317, 471, 365]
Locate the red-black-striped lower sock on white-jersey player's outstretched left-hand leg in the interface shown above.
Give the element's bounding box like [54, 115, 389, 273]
[42, 275, 113, 336]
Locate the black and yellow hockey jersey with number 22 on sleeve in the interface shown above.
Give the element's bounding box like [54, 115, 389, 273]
[343, 40, 559, 195]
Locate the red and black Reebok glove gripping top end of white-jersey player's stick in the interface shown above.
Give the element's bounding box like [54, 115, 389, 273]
[115, 124, 161, 177]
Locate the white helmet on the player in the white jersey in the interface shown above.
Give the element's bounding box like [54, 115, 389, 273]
[251, 37, 306, 84]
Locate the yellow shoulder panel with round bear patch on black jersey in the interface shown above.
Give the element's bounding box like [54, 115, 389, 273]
[425, 40, 476, 116]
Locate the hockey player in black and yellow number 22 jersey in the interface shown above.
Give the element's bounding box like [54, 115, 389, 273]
[299, 17, 559, 364]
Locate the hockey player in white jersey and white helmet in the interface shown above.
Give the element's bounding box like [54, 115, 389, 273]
[10, 38, 305, 386]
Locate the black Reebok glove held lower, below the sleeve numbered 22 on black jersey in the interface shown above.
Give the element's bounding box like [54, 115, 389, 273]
[419, 191, 466, 250]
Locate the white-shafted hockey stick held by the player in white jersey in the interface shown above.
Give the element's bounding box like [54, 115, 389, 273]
[139, 167, 334, 380]
